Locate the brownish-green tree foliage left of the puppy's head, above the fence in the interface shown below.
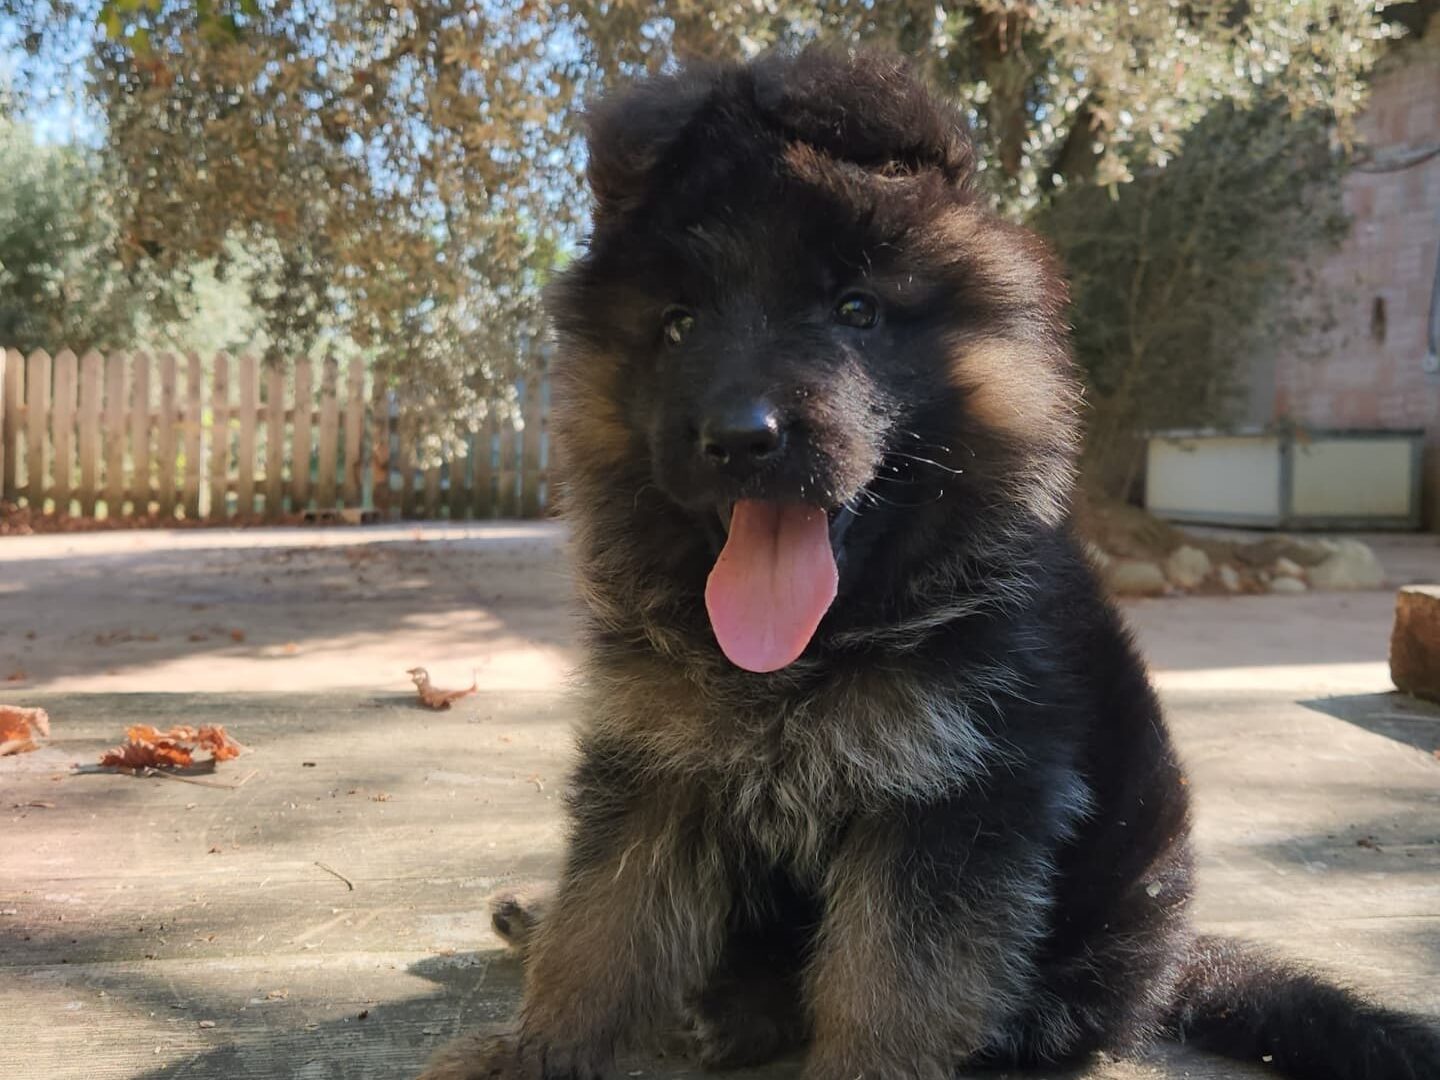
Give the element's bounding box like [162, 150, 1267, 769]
[18, 0, 583, 449]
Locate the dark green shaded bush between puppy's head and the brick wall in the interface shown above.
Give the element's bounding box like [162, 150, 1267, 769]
[1034, 102, 1345, 492]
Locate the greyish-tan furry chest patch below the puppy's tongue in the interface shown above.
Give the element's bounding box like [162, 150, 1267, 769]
[590, 662, 1001, 867]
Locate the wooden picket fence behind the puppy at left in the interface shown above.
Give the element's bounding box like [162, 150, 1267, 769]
[0, 350, 549, 521]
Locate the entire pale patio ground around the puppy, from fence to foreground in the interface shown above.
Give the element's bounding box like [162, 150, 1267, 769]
[0, 526, 1440, 1080]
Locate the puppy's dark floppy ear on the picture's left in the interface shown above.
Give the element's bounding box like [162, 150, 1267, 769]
[585, 65, 716, 222]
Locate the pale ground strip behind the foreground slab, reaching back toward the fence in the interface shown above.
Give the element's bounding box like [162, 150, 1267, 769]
[0, 523, 1440, 700]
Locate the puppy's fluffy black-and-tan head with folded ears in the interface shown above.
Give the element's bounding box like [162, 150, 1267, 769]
[552, 49, 1076, 673]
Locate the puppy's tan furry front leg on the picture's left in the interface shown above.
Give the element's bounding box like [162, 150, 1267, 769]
[518, 796, 730, 1080]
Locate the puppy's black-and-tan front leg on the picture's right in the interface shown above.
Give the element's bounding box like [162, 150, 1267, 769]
[805, 805, 1048, 1080]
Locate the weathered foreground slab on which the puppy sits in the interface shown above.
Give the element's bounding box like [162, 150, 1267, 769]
[0, 684, 1440, 1080]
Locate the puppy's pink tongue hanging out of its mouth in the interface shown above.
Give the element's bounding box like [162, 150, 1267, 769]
[706, 500, 838, 671]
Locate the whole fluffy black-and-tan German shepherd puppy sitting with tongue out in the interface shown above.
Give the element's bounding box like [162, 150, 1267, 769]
[428, 49, 1440, 1080]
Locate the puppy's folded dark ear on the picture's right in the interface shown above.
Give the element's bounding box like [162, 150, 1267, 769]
[753, 46, 975, 186]
